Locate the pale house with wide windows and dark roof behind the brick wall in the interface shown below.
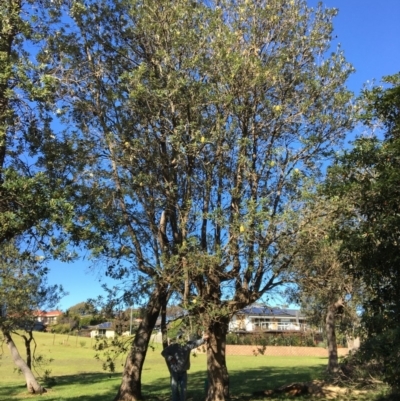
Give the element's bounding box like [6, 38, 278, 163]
[229, 304, 309, 332]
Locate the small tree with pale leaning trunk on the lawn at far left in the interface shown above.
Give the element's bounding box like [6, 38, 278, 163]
[0, 243, 64, 394]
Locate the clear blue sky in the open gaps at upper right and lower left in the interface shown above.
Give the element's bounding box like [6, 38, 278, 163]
[49, 0, 400, 310]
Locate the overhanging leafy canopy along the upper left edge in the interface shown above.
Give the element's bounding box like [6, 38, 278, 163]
[0, 0, 72, 247]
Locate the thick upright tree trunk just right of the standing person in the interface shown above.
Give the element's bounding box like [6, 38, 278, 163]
[206, 318, 229, 401]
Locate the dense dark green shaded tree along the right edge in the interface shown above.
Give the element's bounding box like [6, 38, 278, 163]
[327, 74, 400, 392]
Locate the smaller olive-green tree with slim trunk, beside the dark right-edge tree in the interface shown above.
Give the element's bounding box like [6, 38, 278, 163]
[287, 197, 362, 376]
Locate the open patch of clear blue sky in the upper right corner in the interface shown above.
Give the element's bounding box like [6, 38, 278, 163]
[308, 0, 400, 93]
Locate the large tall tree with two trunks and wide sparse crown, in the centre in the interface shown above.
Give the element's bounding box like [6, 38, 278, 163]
[49, 0, 352, 401]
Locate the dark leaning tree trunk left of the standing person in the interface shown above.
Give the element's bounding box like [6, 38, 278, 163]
[114, 284, 167, 401]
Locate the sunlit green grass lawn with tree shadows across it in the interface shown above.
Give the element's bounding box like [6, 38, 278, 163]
[0, 333, 386, 401]
